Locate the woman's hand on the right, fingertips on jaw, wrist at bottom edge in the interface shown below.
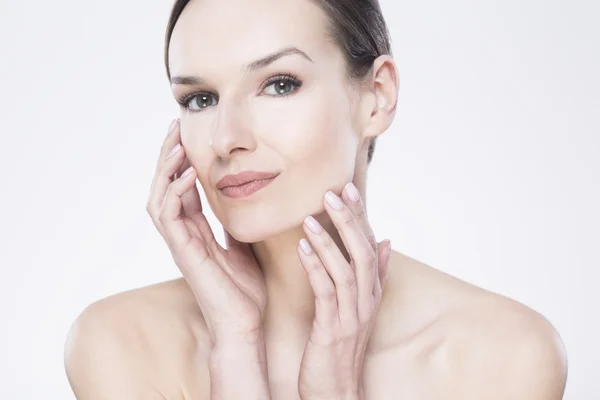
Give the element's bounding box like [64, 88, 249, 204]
[297, 183, 390, 400]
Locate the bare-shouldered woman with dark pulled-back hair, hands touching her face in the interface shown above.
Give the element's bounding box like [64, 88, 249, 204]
[65, 0, 566, 400]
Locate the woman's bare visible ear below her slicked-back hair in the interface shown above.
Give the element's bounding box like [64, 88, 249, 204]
[359, 54, 400, 138]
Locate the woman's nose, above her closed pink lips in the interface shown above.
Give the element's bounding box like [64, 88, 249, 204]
[210, 99, 256, 159]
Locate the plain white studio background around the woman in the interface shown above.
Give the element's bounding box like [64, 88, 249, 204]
[0, 0, 600, 400]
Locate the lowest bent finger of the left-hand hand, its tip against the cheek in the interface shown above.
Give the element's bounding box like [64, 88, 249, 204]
[158, 168, 198, 256]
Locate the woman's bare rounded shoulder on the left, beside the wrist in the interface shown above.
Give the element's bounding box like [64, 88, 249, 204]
[64, 279, 210, 400]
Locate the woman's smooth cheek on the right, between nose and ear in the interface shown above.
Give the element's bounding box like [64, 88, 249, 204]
[248, 85, 359, 225]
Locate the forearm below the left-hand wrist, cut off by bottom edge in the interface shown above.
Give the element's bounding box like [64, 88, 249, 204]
[209, 340, 271, 400]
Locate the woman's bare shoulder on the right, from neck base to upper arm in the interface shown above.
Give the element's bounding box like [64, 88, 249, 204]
[388, 253, 567, 400]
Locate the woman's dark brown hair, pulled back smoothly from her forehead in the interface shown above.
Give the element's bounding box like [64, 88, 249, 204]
[165, 0, 392, 163]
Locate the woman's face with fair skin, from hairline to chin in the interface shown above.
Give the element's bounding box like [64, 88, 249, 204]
[169, 0, 367, 242]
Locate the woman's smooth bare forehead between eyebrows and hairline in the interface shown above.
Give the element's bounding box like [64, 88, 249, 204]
[169, 0, 336, 75]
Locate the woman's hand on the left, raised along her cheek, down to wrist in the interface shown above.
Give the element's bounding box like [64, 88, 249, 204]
[146, 120, 267, 345]
